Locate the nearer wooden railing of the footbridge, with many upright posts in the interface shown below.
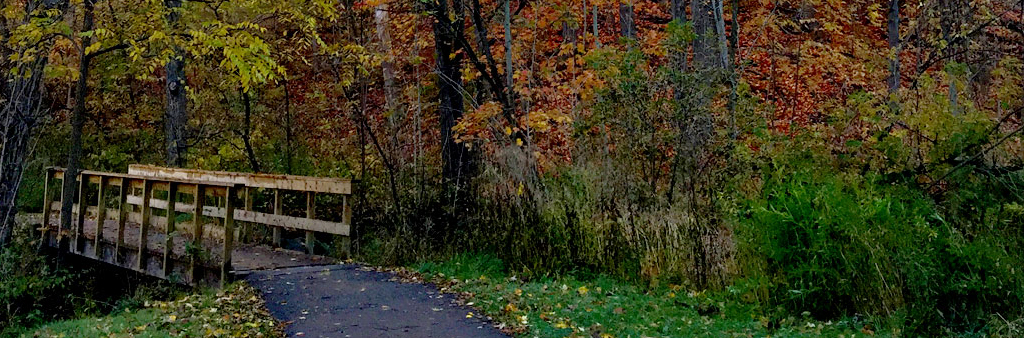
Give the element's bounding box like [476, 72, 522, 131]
[40, 168, 242, 284]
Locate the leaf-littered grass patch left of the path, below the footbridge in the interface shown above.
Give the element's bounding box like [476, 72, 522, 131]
[23, 283, 282, 338]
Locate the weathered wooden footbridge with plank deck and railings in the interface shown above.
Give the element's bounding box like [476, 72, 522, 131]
[39, 165, 352, 286]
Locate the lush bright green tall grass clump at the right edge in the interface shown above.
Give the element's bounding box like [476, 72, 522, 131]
[735, 121, 1024, 336]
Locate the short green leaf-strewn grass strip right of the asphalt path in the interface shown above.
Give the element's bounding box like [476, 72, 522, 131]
[419, 255, 886, 338]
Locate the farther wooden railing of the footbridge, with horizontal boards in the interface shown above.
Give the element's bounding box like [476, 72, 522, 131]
[128, 165, 352, 255]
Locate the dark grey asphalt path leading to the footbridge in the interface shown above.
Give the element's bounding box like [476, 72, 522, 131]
[246, 264, 508, 338]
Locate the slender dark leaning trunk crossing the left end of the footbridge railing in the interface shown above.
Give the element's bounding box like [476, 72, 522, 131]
[60, 0, 95, 242]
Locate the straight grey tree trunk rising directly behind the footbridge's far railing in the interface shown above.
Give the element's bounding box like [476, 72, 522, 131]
[164, 0, 188, 167]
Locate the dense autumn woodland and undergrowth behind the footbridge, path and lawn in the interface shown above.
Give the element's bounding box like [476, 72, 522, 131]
[0, 0, 1024, 336]
